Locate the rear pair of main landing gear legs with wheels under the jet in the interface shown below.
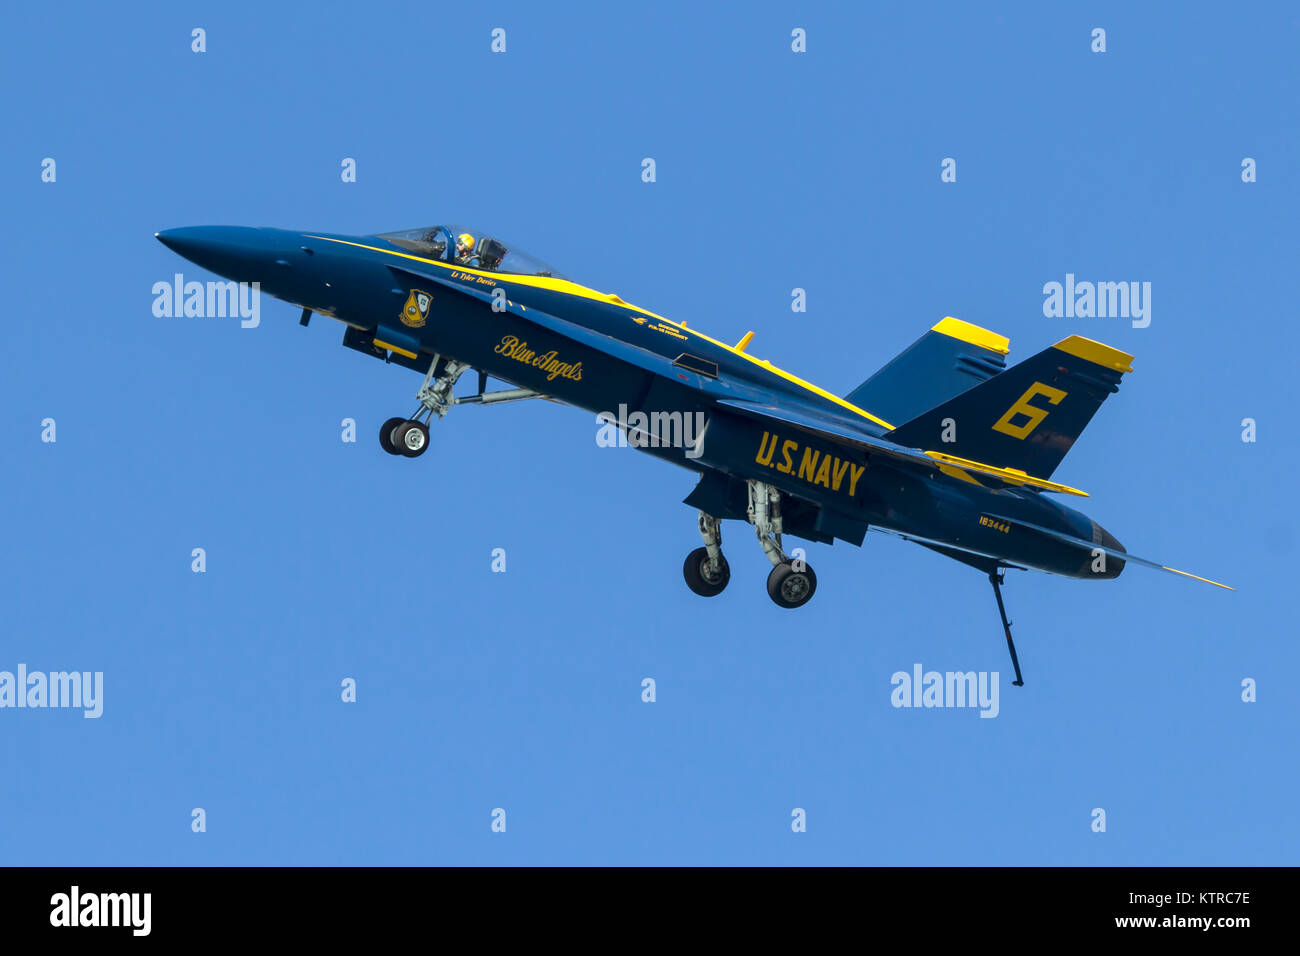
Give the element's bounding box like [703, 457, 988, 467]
[681, 480, 816, 607]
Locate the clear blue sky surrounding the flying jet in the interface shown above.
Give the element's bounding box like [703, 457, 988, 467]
[0, 3, 1300, 865]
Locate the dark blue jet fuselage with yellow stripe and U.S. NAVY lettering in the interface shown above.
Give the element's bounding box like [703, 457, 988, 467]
[159, 226, 1123, 578]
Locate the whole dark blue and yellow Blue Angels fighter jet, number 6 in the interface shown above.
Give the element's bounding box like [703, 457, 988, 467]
[157, 225, 1227, 685]
